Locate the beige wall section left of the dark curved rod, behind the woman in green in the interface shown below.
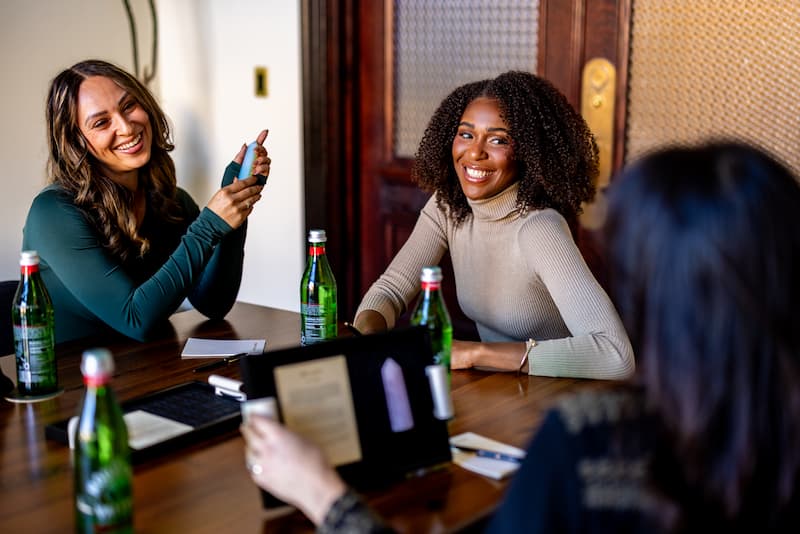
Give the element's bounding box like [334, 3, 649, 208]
[0, 0, 142, 279]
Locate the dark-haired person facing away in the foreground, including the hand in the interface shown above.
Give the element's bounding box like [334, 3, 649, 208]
[242, 142, 800, 534]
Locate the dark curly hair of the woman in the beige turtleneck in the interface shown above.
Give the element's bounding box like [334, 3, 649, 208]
[412, 71, 598, 224]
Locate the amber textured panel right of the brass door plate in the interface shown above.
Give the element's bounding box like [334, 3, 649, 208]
[626, 0, 800, 173]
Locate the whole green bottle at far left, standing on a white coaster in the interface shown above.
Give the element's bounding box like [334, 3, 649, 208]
[11, 250, 58, 396]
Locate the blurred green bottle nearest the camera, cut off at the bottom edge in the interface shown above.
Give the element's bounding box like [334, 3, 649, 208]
[73, 349, 133, 533]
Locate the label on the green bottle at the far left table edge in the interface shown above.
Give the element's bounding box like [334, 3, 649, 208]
[14, 324, 58, 393]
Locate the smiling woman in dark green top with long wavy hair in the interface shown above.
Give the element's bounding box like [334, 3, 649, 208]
[22, 60, 271, 342]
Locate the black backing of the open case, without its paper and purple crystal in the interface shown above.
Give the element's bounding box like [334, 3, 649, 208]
[241, 327, 452, 506]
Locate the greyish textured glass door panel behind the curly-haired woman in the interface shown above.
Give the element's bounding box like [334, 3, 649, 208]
[392, 0, 539, 157]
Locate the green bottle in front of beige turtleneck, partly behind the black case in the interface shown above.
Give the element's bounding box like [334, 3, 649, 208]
[411, 266, 453, 376]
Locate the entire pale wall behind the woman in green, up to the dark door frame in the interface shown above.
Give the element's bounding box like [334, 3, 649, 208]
[0, 0, 304, 310]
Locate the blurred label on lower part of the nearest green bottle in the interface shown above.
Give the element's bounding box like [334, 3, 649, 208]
[75, 458, 133, 532]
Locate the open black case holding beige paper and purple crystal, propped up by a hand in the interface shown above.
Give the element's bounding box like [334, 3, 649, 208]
[241, 327, 452, 507]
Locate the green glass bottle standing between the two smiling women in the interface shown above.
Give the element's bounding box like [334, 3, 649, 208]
[300, 230, 338, 345]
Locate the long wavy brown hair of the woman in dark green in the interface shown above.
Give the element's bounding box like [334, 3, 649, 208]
[45, 60, 182, 262]
